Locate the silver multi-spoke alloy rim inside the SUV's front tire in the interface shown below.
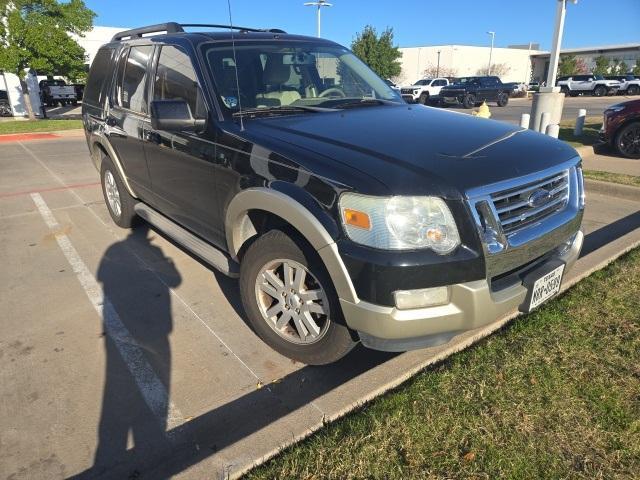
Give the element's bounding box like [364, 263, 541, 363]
[255, 259, 331, 345]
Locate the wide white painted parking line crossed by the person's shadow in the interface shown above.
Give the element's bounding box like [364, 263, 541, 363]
[31, 193, 184, 436]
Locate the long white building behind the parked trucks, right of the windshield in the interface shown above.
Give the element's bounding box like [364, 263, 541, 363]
[396, 45, 544, 85]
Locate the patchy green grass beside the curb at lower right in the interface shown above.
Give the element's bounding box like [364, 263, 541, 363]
[247, 249, 640, 480]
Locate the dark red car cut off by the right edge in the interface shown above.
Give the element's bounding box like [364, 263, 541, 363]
[600, 100, 640, 159]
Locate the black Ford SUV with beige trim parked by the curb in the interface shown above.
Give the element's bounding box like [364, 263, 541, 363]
[82, 23, 584, 364]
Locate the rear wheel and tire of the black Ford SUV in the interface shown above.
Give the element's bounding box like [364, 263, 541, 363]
[100, 155, 137, 228]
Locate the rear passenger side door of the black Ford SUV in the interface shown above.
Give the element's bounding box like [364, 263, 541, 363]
[106, 45, 154, 198]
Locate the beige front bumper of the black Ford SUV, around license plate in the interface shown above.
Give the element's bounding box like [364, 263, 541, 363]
[340, 231, 584, 351]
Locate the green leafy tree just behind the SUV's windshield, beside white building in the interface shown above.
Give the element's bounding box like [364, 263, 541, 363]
[351, 25, 402, 78]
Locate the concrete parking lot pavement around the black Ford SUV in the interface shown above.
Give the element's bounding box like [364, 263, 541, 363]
[0, 133, 640, 480]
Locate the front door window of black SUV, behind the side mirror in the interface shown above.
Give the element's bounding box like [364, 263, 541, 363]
[153, 46, 205, 118]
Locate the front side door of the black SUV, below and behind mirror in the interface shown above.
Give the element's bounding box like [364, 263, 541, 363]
[144, 45, 224, 246]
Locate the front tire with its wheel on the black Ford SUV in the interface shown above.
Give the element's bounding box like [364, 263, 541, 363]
[240, 230, 356, 365]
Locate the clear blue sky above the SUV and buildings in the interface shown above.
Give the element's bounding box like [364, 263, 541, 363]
[85, 0, 640, 49]
